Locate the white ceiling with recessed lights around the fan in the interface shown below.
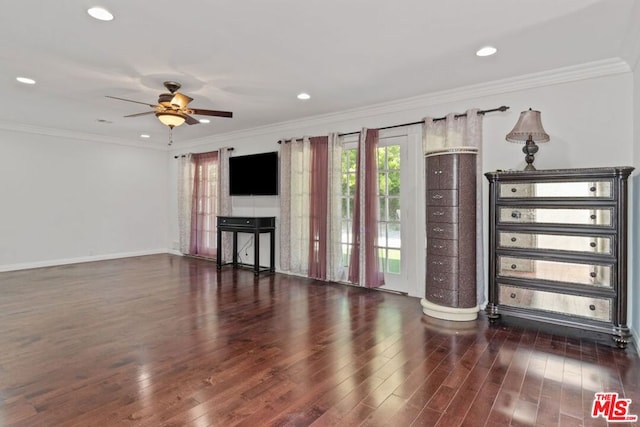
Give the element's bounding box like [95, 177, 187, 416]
[0, 0, 640, 145]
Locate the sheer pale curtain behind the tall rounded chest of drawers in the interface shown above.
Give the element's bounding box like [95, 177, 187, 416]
[422, 108, 485, 305]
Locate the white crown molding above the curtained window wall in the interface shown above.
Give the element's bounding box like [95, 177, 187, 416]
[180, 58, 632, 149]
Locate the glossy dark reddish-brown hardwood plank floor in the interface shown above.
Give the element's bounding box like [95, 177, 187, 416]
[0, 255, 640, 426]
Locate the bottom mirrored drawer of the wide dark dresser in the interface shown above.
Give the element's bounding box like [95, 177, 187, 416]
[498, 284, 612, 322]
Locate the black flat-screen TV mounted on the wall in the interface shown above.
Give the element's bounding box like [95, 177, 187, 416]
[229, 151, 280, 196]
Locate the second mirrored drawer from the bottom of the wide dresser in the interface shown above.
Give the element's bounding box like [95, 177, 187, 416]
[497, 256, 613, 288]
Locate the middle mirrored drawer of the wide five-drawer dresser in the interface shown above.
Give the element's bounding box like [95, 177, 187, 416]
[497, 231, 613, 255]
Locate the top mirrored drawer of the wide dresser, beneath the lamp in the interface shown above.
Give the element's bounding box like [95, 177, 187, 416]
[498, 180, 613, 199]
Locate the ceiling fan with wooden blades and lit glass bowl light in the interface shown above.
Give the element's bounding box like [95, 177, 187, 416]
[106, 81, 233, 129]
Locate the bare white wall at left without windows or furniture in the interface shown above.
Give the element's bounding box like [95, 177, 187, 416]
[0, 130, 168, 270]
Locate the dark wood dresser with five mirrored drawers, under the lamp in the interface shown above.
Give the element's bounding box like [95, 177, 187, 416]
[485, 167, 633, 348]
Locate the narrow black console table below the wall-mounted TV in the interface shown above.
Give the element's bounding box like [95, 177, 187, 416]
[216, 216, 276, 276]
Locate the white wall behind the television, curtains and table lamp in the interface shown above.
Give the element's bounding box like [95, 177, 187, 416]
[169, 64, 633, 304]
